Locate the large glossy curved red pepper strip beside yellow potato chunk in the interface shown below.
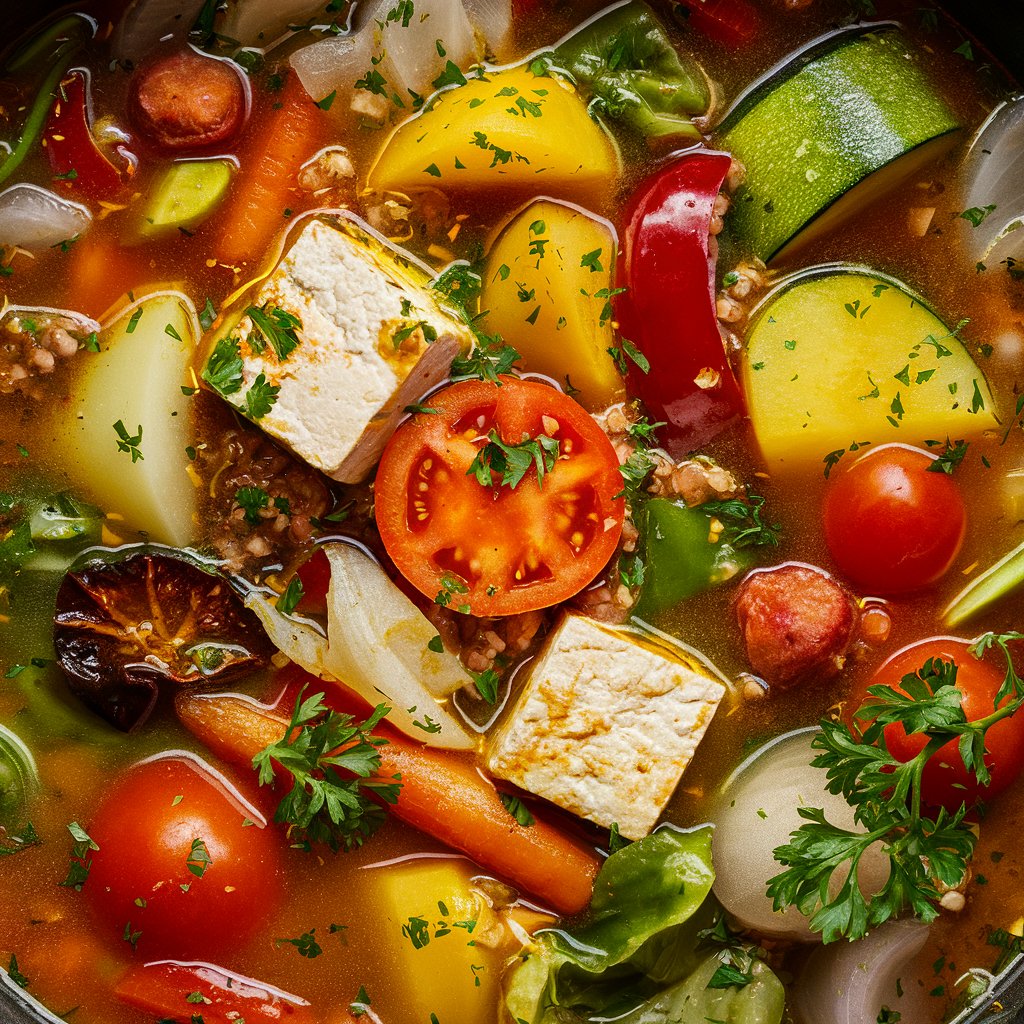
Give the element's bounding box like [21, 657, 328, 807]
[615, 150, 743, 458]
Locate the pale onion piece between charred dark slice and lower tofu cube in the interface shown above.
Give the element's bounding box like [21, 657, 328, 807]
[324, 544, 475, 750]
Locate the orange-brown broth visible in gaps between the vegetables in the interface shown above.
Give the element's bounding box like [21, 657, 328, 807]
[0, 0, 1024, 1024]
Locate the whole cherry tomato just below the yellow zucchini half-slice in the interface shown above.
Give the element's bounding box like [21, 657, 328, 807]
[824, 444, 967, 594]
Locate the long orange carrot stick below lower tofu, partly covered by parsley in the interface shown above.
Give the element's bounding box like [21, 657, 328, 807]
[175, 693, 599, 913]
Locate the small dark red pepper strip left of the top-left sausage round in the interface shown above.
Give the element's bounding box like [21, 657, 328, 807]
[43, 71, 123, 199]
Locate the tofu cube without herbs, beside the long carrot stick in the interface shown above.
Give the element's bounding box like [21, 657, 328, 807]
[487, 613, 725, 840]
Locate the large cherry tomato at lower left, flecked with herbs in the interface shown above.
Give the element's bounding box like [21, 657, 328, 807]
[84, 757, 281, 956]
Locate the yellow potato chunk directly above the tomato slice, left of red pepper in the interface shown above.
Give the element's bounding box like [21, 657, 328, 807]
[480, 200, 625, 410]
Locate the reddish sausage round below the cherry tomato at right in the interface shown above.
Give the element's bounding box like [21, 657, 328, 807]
[735, 562, 855, 687]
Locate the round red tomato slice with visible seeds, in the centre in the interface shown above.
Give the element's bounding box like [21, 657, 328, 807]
[375, 377, 625, 615]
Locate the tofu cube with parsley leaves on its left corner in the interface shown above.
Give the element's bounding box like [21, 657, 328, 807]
[204, 212, 472, 483]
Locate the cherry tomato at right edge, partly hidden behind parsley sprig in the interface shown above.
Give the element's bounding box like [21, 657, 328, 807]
[849, 637, 1024, 811]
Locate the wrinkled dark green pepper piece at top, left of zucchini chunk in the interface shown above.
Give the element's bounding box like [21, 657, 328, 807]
[554, 0, 710, 140]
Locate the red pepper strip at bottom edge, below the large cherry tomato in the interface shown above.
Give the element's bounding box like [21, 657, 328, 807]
[114, 961, 314, 1024]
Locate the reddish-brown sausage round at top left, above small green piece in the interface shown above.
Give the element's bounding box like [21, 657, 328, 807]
[129, 50, 248, 152]
